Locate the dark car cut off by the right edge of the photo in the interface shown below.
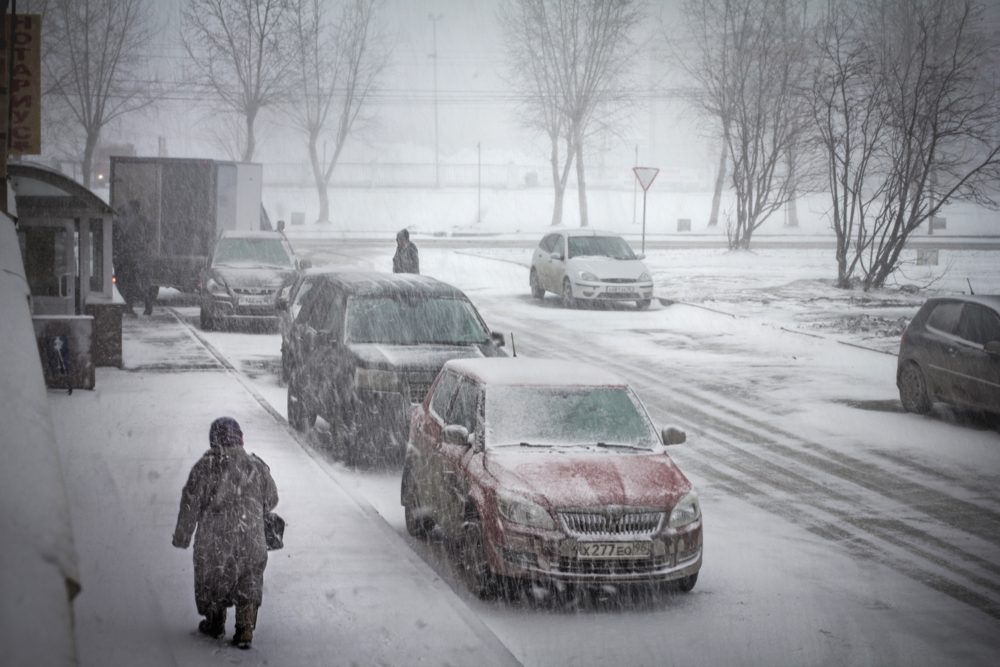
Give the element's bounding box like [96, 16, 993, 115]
[896, 296, 1000, 413]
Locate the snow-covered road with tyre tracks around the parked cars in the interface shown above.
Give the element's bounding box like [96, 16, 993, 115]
[126, 241, 1000, 665]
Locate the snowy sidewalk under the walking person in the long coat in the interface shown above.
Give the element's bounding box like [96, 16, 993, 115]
[49, 318, 518, 667]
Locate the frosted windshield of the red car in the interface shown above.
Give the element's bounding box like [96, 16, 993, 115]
[485, 386, 660, 449]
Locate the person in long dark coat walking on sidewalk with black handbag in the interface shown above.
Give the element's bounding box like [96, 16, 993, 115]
[173, 417, 278, 649]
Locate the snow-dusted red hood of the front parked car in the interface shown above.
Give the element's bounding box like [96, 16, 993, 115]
[485, 448, 691, 510]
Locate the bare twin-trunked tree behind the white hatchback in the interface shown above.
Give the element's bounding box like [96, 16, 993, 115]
[498, 0, 644, 227]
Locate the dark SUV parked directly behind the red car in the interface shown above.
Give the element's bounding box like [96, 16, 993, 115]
[288, 272, 506, 464]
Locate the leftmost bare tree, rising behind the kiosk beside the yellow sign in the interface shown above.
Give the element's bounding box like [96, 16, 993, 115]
[40, 0, 160, 187]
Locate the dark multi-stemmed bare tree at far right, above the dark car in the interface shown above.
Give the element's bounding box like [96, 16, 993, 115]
[813, 0, 1000, 290]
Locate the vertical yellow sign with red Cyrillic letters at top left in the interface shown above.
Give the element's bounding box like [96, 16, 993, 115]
[0, 14, 42, 155]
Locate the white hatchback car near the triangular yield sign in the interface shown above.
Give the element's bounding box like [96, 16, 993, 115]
[528, 229, 653, 310]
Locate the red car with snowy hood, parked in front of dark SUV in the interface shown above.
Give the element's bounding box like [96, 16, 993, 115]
[401, 357, 702, 597]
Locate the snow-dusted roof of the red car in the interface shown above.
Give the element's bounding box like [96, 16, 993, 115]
[444, 357, 628, 387]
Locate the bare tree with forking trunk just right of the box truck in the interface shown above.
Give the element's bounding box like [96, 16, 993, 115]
[288, 0, 393, 222]
